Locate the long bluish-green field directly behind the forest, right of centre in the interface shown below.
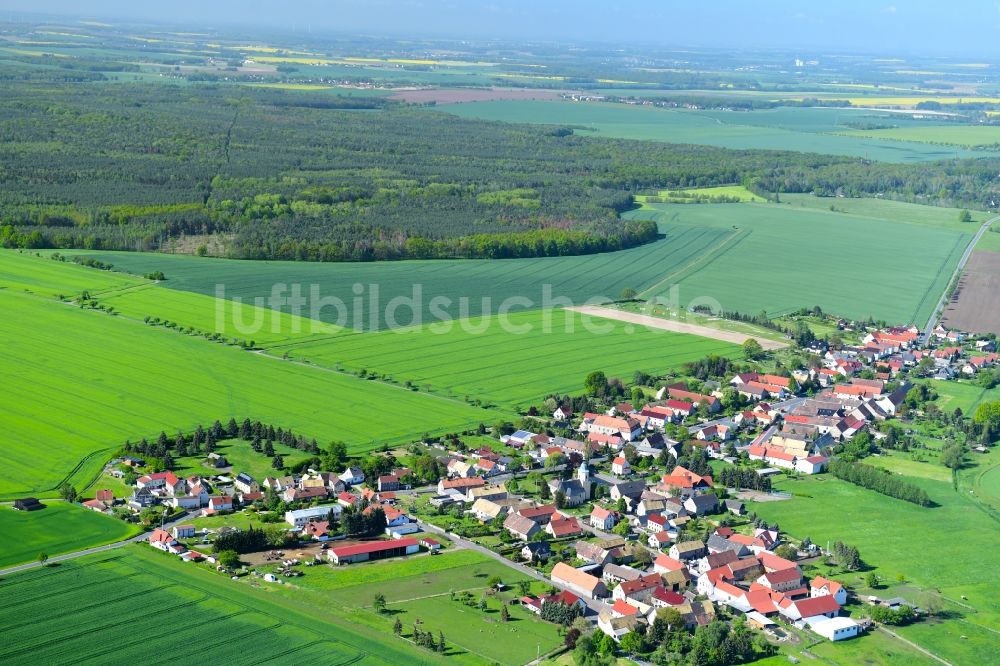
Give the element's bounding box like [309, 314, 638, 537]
[441, 101, 995, 162]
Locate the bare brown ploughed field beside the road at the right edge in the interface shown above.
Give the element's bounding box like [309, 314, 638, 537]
[943, 250, 1000, 333]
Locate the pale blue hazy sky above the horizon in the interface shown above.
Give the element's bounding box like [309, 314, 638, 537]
[0, 0, 1000, 58]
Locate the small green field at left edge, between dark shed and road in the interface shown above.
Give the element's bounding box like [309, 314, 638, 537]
[0, 501, 139, 568]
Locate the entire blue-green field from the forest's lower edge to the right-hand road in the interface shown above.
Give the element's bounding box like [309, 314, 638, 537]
[50, 191, 975, 330]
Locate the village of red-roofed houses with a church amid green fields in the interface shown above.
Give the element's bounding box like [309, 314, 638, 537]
[47, 314, 1000, 656]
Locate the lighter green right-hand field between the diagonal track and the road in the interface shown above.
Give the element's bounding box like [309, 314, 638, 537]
[630, 204, 970, 323]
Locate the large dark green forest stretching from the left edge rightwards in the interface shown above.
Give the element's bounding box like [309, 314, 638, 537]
[0, 81, 1000, 261]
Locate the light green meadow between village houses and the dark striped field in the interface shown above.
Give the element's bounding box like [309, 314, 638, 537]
[262, 550, 562, 666]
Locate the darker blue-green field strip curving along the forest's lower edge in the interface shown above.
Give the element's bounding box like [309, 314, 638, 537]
[54, 226, 732, 331]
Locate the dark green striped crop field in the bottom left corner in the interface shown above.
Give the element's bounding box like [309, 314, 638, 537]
[0, 545, 444, 665]
